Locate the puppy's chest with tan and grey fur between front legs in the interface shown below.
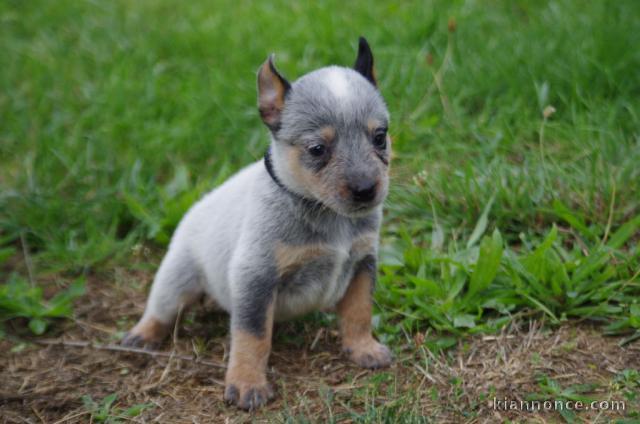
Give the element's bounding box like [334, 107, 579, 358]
[276, 234, 377, 317]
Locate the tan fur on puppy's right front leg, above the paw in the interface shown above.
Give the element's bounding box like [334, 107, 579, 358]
[336, 271, 373, 349]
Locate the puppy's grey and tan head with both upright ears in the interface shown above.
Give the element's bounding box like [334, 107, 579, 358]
[258, 38, 391, 216]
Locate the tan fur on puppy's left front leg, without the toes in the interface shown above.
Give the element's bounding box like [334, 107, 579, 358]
[225, 298, 275, 388]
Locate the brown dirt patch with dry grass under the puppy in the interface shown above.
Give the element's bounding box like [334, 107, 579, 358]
[0, 270, 640, 423]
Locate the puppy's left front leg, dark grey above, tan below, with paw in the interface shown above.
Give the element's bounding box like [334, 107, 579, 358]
[224, 284, 275, 410]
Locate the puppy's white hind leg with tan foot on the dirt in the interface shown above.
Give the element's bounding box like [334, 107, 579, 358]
[122, 249, 203, 346]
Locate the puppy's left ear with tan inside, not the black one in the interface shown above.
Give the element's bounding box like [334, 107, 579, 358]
[258, 54, 291, 132]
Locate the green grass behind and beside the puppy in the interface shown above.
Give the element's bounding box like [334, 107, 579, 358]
[0, 0, 640, 421]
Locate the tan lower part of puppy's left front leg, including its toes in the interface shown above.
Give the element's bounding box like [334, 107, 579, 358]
[224, 302, 274, 410]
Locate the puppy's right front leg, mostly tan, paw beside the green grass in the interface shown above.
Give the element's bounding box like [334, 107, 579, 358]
[337, 256, 391, 368]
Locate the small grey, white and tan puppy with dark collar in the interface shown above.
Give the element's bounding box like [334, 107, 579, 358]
[123, 38, 392, 410]
